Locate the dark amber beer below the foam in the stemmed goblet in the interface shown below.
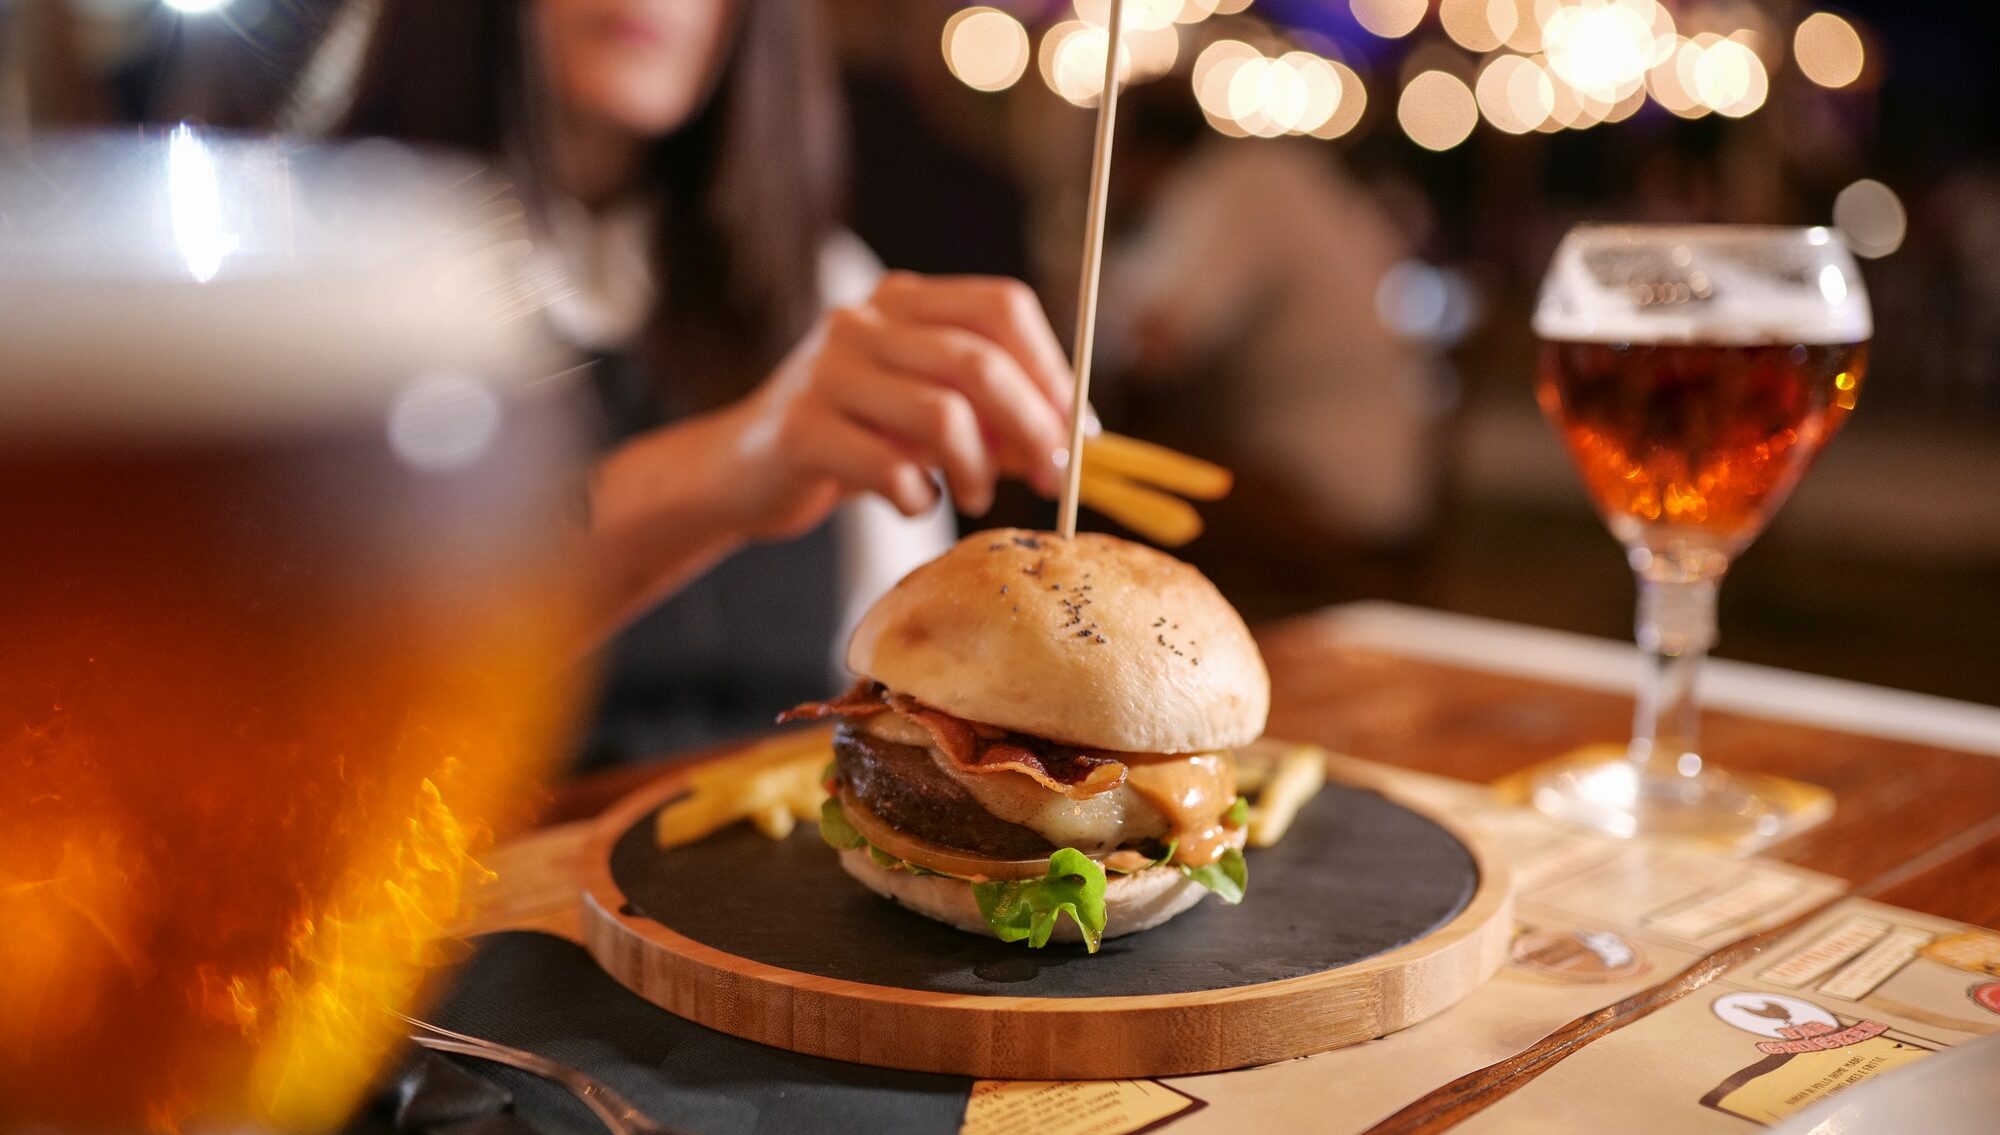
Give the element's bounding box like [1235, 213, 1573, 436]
[1536, 342, 1868, 556]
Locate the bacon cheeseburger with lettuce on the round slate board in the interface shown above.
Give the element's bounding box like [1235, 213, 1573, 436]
[780, 530, 1270, 951]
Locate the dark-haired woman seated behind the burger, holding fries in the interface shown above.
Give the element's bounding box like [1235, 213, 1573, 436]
[119, 0, 1070, 761]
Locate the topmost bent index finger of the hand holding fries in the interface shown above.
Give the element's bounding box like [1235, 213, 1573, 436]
[870, 272, 1076, 413]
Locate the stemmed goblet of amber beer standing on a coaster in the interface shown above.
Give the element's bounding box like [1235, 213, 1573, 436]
[1530, 226, 1874, 847]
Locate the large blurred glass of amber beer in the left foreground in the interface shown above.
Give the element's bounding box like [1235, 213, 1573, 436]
[0, 128, 582, 1133]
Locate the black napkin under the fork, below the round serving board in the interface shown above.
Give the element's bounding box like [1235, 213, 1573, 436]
[348, 931, 972, 1135]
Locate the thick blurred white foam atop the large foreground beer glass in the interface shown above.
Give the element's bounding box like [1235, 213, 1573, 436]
[0, 128, 564, 434]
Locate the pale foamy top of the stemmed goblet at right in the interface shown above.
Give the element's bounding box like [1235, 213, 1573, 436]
[1534, 226, 1874, 346]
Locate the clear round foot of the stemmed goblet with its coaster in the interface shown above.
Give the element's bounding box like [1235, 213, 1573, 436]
[1520, 745, 1834, 855]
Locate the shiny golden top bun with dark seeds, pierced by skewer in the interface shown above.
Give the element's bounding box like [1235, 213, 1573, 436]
[848, 528, 1270, 753]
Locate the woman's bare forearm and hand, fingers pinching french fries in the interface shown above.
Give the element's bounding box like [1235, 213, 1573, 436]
[588, 272, 1074, 625]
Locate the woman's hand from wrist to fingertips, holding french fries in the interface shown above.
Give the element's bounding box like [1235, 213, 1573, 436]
[718, 272, 1072, 538]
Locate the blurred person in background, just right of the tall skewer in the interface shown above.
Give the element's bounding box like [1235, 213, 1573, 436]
[1104, 82, 1438, 615]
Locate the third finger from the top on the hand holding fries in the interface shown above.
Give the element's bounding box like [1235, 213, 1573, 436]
[820, 360, 1000, 516]
